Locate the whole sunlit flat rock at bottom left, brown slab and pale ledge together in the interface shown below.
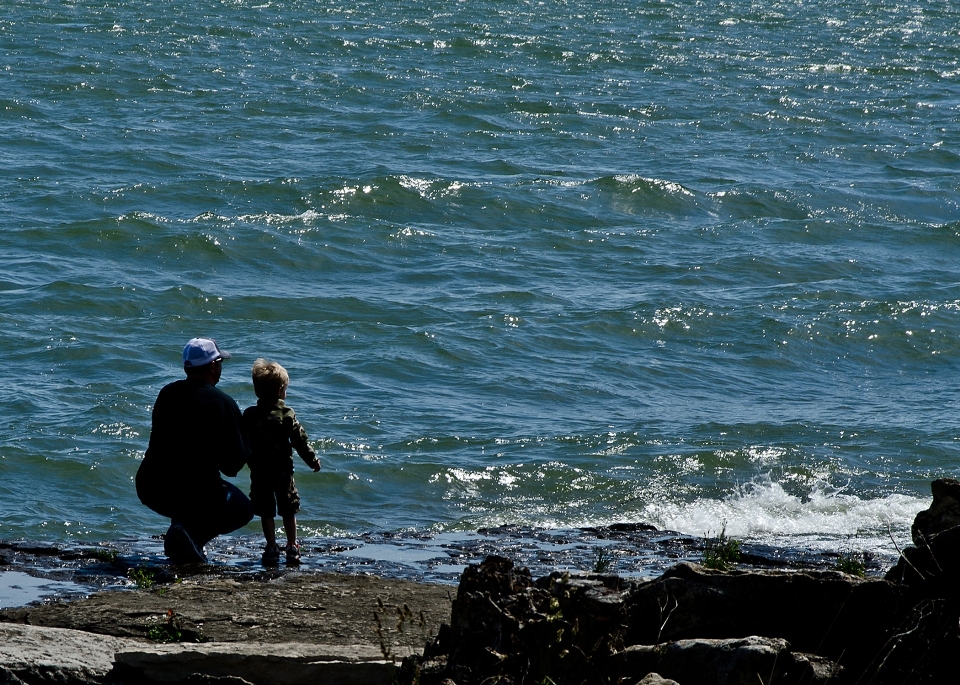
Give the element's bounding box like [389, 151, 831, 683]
[0, 574, 452, 685]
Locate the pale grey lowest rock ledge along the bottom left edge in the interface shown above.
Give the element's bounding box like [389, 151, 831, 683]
[0, 624, 413, 685]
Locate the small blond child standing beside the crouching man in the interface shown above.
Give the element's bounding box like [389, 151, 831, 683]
[243, 359, 320, 564]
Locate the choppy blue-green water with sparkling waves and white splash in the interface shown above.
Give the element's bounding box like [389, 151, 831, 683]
[0, 0, 960, 568]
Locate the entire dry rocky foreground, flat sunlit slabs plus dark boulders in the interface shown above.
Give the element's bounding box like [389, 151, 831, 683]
[0, 479, 960, 685]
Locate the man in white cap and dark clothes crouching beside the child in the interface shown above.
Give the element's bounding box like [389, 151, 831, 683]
[136, 338, 253, 564]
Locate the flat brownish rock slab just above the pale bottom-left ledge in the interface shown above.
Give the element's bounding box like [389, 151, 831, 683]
[0, 573, 454, 652]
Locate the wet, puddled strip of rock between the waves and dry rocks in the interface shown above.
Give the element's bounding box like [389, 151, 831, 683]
[0, 522, 896, 609]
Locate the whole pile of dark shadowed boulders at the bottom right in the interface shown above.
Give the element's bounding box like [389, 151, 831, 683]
[399, 479, 960, 685]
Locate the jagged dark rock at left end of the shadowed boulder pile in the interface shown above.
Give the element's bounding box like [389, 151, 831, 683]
[410, 557, 632, 685]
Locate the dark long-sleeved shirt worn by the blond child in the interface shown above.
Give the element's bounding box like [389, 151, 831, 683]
[243, 399, 320, 473]
